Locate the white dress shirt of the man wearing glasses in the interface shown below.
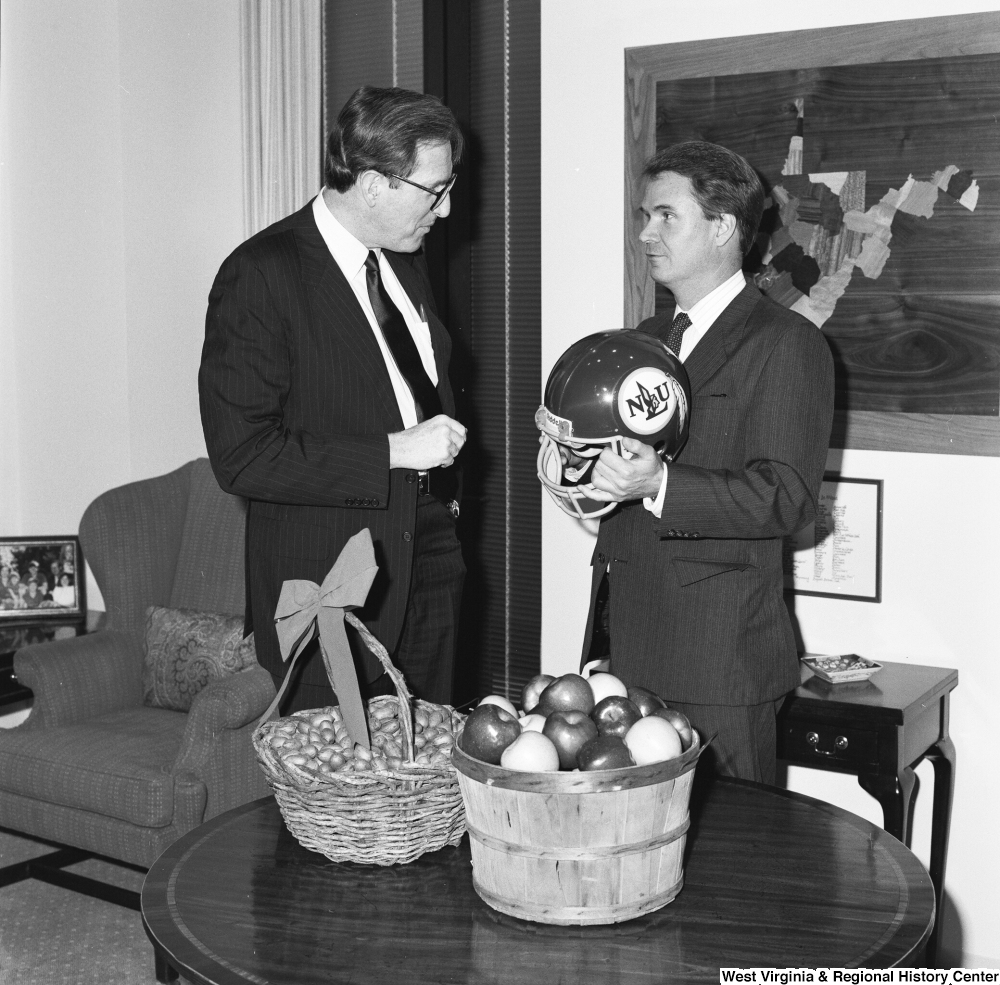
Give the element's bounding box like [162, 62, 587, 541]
[313, 191, 438, 428]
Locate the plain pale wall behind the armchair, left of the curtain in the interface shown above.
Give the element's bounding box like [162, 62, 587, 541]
[0, 0, 243, 588]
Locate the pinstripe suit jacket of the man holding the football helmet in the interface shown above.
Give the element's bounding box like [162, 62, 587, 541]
[584, 284, 833, 705]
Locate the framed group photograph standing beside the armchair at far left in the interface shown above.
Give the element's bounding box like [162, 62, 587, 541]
[0, 537, 87, 624]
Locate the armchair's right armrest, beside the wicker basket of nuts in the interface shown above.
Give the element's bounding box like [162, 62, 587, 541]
[174, 665, 274, 776]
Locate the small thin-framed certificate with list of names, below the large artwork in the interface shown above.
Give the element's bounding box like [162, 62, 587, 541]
[784, 472, 882, 602]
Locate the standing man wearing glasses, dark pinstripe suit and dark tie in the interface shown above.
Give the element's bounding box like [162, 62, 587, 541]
[199, 86, 466, 714]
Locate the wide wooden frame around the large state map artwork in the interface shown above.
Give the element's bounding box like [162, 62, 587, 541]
[624, 13, 1000, 456]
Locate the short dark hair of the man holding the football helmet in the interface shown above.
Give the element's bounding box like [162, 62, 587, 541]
[642, 140, 764, 256]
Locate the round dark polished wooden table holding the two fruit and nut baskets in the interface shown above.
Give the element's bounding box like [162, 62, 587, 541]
[142, 780, 934, 985]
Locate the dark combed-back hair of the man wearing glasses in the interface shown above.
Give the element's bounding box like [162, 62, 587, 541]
[324, 86, 464, 192]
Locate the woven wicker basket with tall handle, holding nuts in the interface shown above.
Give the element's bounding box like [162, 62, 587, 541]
[253, 612, 465, 865]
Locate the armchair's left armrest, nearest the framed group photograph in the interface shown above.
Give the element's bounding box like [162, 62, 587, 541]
[14, 630, 142, 728]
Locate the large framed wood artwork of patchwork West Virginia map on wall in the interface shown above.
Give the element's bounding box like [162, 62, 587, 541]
[625, 13, 1000, 455]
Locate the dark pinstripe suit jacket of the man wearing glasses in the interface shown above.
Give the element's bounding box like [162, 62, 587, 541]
[199, 203, 454, 684]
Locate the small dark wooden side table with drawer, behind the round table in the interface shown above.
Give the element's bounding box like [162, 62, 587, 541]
[778, 661, 958, 967]
